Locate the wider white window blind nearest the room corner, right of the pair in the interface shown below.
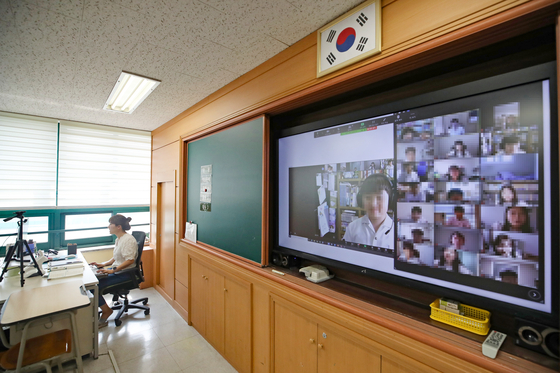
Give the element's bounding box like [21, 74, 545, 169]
[58, 121, 151, 206]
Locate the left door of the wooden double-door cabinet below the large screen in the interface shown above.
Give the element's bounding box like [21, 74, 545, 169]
[274, 302, 318, 373]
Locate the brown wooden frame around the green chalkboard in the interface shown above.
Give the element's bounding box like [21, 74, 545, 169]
[179, 115, 270, 267]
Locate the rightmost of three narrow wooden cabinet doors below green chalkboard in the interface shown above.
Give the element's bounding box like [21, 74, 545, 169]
[224, 277, 252, 372]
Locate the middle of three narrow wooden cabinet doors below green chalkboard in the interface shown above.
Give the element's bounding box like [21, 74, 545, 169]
[204, 268, 224, 355]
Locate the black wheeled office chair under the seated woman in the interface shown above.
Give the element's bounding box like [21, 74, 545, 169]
[102, 231, 150, 326]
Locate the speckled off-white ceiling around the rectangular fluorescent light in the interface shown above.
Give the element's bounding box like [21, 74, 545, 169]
[0, 0, 362, 131]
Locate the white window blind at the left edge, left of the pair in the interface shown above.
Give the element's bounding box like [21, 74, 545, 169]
[0, 113, 58, 208]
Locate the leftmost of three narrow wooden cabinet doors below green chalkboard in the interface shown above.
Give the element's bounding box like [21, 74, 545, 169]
[189, 260, 208, 336]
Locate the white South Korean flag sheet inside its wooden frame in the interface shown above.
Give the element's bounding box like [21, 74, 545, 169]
[319, 1, 381, 74]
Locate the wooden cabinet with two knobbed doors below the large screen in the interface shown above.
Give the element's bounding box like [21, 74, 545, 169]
[273, 298, 381, 373]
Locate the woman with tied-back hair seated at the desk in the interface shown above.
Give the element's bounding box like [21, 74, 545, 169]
[90, 214, 138, 328]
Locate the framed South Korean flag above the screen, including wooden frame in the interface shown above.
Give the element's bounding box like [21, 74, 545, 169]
[317, 0, 381, 77]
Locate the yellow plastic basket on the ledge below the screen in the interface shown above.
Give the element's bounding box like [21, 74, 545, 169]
[430, 299, 490, 335]
